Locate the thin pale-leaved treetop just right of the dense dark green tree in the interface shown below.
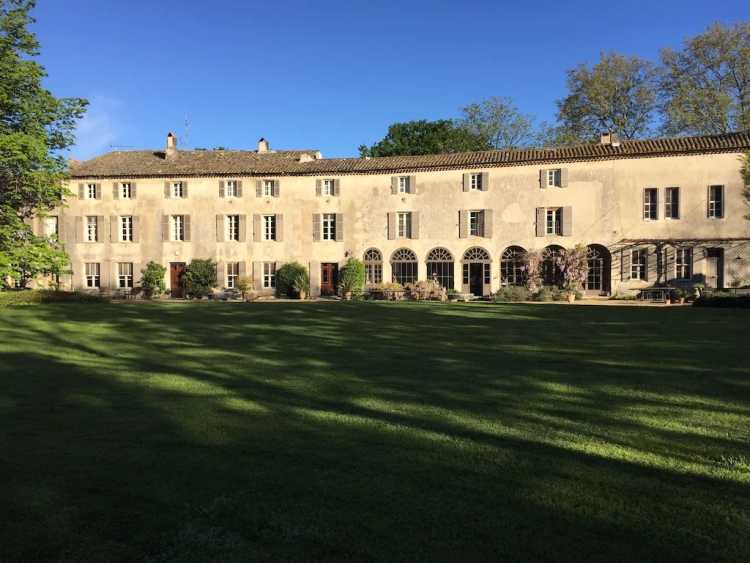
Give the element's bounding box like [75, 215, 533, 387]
[456, 96, 539, 150]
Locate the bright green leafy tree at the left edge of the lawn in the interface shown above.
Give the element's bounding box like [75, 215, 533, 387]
[0, 0, 88, 285]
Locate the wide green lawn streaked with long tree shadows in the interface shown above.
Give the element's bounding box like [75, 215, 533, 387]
[0, 302, 750, 563]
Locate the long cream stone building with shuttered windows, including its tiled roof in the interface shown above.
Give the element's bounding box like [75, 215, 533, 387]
[36, 133, 750, 296]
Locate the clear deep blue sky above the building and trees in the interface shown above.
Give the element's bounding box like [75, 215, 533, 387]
[32, 0, 750, 160]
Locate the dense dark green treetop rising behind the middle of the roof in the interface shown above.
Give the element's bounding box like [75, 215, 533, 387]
[359, 119, 487, 158]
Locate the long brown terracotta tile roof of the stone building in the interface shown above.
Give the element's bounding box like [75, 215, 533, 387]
[70, 132, 750, 178]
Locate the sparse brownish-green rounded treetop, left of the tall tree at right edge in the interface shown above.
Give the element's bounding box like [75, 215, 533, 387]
[556, 51, 659, 142]
